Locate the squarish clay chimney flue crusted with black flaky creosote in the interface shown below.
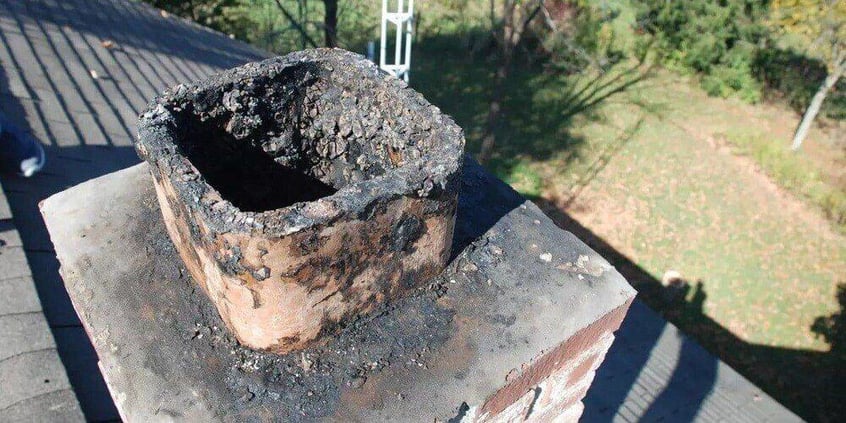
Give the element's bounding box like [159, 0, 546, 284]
[136, 49, 464, 353]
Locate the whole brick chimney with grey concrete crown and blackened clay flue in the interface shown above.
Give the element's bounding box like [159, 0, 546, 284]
[41, 50, 635, 423]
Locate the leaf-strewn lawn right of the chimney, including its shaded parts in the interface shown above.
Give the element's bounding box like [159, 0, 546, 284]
[412, 39, 846, 421]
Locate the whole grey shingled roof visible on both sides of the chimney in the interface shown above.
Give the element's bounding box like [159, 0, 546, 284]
[0, 0, 797, 421]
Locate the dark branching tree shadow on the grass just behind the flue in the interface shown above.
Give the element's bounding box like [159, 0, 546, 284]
[411, 30, 651, 189]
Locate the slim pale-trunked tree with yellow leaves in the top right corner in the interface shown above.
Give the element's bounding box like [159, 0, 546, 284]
[773, 0, 846, 151]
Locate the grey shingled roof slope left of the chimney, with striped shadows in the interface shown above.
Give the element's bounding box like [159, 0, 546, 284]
[0, 0, 266, 421]
